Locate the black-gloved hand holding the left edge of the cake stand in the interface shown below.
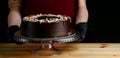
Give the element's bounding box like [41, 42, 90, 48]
[8, 25, 22, 44]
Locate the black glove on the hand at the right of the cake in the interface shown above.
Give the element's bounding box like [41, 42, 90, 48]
[74, 22, 88, 40]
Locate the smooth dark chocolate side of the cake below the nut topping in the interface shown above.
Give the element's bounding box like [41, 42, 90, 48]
[21, 20, 71, 38]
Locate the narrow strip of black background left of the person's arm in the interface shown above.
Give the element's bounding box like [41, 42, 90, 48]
[0, 0, 9, 42]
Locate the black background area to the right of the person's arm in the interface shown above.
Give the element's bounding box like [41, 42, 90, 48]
[84, 0, 120, 43]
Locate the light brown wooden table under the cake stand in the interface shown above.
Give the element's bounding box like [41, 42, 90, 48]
[0, 43, 120, 58]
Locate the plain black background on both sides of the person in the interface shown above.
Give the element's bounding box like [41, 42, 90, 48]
[0, 0, 120, 43]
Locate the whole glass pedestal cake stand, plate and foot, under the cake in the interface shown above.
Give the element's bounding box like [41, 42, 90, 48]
[14, 31, 81, 56]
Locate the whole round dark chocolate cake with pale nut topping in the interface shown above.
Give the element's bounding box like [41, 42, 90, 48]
[21, 14, 74, 38]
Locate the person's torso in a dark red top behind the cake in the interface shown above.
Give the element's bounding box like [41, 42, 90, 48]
[23, 0, 76, 18]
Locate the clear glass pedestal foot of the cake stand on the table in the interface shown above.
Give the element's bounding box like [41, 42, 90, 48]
[32, 43, 62, 56]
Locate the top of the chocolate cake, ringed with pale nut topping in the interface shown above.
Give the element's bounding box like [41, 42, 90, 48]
[23, 14, 71, 23]
